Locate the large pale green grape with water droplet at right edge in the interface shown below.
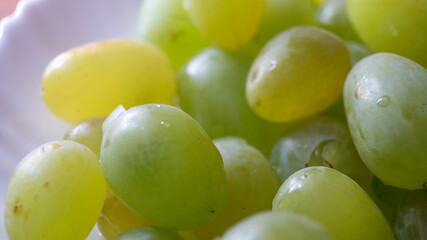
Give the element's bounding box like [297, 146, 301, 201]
[344, 53, 427, 189]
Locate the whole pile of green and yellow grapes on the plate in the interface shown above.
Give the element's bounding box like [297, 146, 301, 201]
[4, 0, 427, 240]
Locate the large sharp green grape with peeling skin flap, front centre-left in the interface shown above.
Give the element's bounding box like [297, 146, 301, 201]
[100, 104, 226, 230]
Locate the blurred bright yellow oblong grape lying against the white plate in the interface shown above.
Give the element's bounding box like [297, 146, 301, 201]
[41, 40, 176, 122]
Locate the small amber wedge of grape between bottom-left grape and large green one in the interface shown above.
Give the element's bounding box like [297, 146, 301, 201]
[98, 189, 151, 240]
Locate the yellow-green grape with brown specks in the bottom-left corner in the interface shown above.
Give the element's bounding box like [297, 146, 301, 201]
[4, 140, 105, 240]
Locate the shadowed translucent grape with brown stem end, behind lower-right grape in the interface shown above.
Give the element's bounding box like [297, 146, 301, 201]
[270, 117, 373, 189]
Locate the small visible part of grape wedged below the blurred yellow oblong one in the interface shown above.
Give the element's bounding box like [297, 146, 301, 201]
[64, 116, 105, 159]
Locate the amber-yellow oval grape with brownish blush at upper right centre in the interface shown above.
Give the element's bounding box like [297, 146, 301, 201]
[246, 27, 350, 122]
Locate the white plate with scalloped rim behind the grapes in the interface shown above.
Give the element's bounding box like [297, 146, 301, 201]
[0, 0, 141, 239]
